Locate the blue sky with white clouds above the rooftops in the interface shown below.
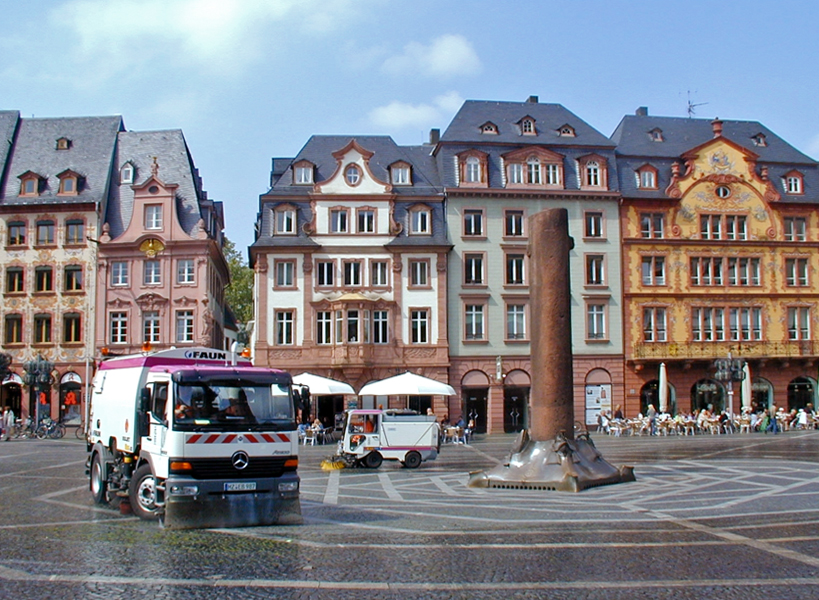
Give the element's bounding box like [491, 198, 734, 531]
[0, 0, 819, 255]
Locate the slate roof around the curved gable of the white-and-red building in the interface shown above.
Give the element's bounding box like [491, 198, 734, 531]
[252, 135, 449, 248]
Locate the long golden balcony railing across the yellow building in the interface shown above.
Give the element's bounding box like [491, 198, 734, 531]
[633, 340, 819, 360]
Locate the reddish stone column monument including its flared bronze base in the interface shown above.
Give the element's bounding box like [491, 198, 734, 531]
[469, 208, 634, 492]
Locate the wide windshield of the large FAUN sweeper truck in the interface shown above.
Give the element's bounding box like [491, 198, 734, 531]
[173, 381, 293, 430]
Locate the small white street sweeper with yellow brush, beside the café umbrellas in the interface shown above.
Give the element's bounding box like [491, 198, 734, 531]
[338, 409, 441, 469]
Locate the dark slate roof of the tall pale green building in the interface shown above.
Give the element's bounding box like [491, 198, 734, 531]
[435, 100, 618, 193]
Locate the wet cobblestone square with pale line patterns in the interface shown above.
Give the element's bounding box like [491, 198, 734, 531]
[0, 431, 819, 600]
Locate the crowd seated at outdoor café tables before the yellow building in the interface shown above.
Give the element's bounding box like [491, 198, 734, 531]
[597, 404, 819, 436]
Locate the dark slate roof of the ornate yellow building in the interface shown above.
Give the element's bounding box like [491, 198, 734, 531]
[611, 115, 819, 203]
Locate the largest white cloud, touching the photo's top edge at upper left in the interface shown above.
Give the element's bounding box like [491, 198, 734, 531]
[50, 0, 370, 78]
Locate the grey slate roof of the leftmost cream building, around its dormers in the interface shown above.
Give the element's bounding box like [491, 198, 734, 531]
[0, 116, 123, 205]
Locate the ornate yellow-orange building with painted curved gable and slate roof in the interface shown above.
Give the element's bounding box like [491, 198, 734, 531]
[612, 108, 819, 414]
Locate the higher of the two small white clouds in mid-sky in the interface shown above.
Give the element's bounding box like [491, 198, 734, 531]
[381, 34, 483, 79]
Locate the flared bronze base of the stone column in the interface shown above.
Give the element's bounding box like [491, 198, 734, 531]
[467, 430, 635, 492]
